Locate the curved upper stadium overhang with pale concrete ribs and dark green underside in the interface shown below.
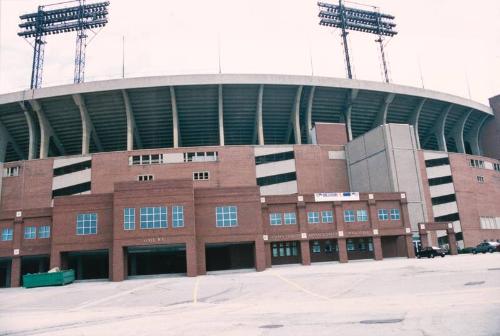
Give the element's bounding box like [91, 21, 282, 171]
[0, 74, 493, 161]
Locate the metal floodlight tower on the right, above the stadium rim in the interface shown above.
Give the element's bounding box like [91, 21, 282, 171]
[318, 0, 397, 83]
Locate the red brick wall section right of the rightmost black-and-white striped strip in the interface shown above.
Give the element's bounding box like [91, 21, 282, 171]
[450, 153, 500, 246]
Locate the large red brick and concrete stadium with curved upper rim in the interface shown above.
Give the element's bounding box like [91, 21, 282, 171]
[0, 74, 500, 287]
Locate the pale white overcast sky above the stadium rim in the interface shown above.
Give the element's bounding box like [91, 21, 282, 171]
[0, 0, 500, 105]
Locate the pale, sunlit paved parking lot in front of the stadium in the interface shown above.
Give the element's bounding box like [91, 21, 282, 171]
[0, 253, 500, 336]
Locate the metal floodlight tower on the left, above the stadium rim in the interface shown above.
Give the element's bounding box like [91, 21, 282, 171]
[17, 0, 109, 89]
